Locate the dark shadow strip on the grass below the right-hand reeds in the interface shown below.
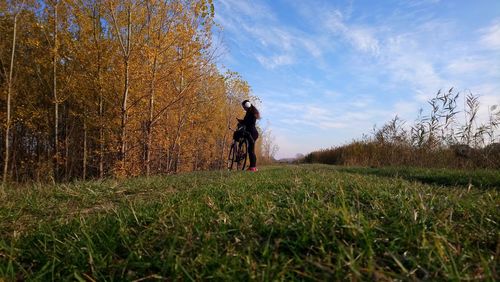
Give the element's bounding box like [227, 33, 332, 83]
[337, 167, 500, 188]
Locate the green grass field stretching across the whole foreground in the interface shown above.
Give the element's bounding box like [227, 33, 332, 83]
[0, 165, 500, 281]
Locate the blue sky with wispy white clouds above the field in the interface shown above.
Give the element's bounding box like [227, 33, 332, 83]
[215, 0, 500, 158]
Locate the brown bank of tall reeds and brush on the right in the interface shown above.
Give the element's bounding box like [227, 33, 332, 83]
[303, 89, 500, 169]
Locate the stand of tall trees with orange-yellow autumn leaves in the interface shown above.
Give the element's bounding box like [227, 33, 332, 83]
[0, 0, 258, 181]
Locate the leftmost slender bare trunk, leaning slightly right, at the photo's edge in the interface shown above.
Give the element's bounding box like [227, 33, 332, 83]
[2, 12, 19, 185]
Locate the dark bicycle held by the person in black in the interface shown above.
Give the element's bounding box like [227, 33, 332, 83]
[227, 120, 249, 170]
